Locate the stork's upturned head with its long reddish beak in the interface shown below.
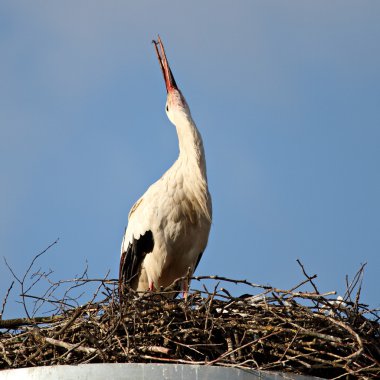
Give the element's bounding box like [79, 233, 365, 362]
[153, 36, 191, 125]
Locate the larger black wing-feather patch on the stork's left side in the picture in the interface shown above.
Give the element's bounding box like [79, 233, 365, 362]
[119, 231, 154, 295]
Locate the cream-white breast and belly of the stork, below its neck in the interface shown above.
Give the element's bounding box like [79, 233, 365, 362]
[143, 165, 211, 286]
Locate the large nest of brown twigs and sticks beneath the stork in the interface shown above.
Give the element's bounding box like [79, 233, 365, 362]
[0, 245, 380, 379]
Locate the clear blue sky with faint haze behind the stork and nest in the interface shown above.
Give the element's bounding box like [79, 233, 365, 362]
[0, 0, 380, 317]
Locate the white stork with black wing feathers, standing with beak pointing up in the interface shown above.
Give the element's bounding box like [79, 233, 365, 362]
[119, 37, 212, 297]
